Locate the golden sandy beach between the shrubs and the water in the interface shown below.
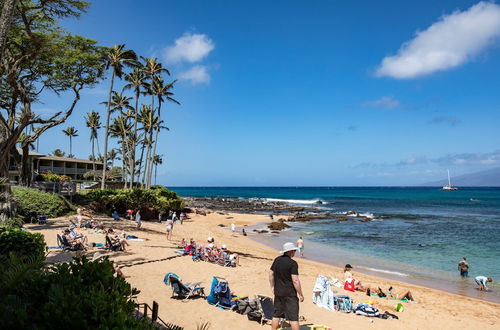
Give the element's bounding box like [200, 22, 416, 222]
[26, 212, 500, 329]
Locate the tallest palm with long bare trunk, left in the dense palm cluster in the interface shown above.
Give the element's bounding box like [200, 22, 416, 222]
[101, 45, 137, 189]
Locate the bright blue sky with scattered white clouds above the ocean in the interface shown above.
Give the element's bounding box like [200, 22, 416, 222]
[33, 0, 500, 186]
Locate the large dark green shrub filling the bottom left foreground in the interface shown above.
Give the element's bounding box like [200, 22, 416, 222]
[0, 257, 158, 329]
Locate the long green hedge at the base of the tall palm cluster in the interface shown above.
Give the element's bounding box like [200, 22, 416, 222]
[81, 186, 184, 213]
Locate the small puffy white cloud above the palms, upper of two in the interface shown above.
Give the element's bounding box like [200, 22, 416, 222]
[163, 33, 215, 63]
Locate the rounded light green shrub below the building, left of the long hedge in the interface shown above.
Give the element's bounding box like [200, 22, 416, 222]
[12, 187, 72, 218]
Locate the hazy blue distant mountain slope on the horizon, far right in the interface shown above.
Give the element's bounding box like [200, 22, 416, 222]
[422, 167, 500, 187]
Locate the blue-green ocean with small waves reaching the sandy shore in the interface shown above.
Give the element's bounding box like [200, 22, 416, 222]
[170, 187, 500, 303]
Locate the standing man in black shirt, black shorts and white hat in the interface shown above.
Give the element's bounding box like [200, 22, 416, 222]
[269, 242, 304, 330]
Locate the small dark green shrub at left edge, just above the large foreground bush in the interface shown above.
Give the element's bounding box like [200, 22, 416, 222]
[0, 227, 45, 262]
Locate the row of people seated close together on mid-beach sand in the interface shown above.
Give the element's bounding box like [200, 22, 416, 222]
[181, 237, 240, 267]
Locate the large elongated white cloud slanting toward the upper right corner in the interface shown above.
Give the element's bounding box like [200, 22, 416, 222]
[376, 2, 500, 79]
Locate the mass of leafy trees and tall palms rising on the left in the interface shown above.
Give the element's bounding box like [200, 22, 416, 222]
[0, 0, 179, 219]
